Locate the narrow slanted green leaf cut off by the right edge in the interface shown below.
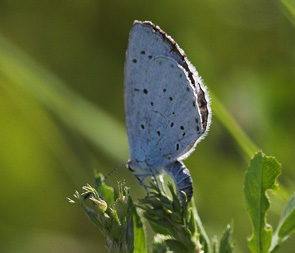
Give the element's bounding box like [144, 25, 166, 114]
[271, 194, 295, 252]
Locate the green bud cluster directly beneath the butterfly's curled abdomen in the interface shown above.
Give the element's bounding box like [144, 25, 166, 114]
[139, 184, 201, 252]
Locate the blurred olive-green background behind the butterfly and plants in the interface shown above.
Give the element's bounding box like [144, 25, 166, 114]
[0, 0, 295, 252]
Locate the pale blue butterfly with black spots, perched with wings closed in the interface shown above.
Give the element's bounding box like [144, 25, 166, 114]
[124, 21, 212, 201]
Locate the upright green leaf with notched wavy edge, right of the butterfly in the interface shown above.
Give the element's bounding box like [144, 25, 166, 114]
[244, 152, 281, 252]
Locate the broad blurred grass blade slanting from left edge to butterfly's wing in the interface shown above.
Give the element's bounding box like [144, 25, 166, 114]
[0, 33, 128, 163]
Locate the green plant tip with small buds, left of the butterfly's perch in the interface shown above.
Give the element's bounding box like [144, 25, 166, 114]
[69, 178, 146, 252]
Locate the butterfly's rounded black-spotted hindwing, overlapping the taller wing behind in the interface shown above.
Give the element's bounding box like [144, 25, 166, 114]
[139, 56, 202, 166]
